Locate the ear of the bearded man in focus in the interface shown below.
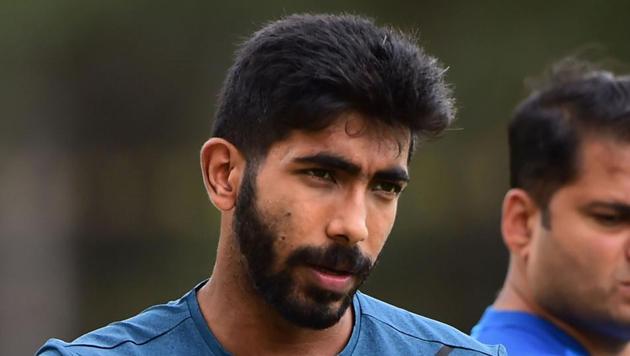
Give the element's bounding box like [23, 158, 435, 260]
[201, 137, 245, 211]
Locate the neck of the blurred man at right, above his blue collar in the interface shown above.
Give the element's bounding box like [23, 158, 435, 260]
[492, 264, 630, 355]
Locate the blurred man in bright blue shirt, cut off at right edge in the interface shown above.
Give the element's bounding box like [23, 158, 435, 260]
[473, 60, 630, 355]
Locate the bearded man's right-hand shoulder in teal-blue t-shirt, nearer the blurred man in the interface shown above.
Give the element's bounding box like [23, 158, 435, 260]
[357, 293, 505, 355]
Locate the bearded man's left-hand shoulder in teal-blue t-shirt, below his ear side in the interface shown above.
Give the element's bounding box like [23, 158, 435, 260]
[37, 298, 198, 356]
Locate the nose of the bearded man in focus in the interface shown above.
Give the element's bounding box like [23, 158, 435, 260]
[326, 191, 368, 245]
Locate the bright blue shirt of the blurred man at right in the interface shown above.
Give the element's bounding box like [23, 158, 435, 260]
[471, 307, 589, 356]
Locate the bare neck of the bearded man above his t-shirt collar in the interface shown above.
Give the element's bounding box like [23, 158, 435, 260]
[197, 232, 354, 355]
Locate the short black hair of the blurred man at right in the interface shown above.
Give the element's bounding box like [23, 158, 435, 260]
[508, 58, 630, 211]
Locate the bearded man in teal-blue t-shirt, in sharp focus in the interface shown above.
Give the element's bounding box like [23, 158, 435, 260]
[40, 15, 502, 355]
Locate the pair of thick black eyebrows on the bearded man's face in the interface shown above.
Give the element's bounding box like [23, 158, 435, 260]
[293, 152, 409, 182]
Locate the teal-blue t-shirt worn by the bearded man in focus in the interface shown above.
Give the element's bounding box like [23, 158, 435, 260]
[37, 284, 505, 356]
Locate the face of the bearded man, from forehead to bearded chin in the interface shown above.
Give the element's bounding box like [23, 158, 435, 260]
[234, 114, 410, 329]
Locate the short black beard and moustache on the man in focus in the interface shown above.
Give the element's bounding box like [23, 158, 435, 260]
[233, 165, 375, 330]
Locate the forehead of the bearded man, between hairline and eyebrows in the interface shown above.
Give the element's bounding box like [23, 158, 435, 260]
[268, 112, 411, 164]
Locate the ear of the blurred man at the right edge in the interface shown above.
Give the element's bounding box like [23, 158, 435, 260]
[501, 188, 539, 260]
